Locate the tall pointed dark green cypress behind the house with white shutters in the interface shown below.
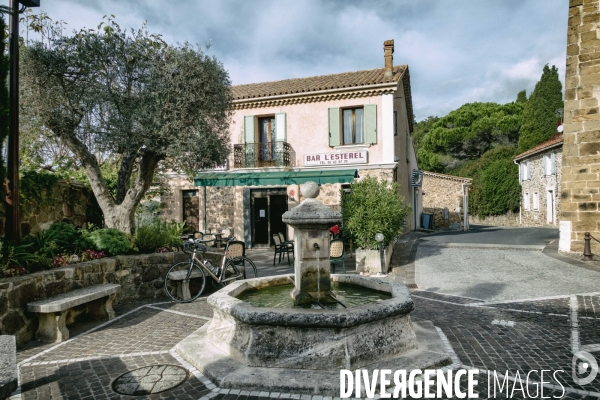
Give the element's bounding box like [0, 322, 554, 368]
[519, 64, 564, 151]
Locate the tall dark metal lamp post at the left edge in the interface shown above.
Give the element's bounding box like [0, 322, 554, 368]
[4, 0, 40, 242]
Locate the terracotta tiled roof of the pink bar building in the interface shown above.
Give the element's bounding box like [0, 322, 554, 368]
[231, 65, 408, 100]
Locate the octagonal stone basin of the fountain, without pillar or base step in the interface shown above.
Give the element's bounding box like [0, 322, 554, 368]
[207, 275, 417, 370]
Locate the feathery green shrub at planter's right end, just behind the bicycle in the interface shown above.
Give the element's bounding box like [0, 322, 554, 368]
[134, 220, 185, 253]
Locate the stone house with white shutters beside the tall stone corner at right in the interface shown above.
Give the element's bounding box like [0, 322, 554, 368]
[514, 132, 563, 226]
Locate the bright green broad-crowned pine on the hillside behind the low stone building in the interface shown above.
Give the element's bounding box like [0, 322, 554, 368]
[418, 103, 523, 172]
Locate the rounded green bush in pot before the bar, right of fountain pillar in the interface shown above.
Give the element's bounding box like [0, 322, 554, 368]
[340, 177, 410, 249]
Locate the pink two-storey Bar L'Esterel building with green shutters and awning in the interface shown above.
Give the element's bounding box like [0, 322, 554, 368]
[161, 40, 421, 247]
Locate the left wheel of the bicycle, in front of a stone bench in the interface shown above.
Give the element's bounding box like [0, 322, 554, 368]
[165, 261, 206, 303]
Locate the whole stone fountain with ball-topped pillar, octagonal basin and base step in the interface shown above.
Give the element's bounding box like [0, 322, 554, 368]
[177, 182, 451, 396]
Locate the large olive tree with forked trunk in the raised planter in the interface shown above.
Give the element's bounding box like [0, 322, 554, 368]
[22, 19, 232, 232]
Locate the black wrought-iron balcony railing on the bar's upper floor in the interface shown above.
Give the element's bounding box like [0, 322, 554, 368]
[233, 142, 295, 168]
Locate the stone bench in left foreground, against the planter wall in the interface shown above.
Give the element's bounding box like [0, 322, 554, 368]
[27, 284, 121, 343]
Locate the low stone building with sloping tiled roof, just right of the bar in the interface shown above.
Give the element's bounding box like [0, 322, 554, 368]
[421, 171, 471, 228]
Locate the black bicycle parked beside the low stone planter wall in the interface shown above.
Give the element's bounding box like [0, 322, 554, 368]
[164, 236, 258, 303]
